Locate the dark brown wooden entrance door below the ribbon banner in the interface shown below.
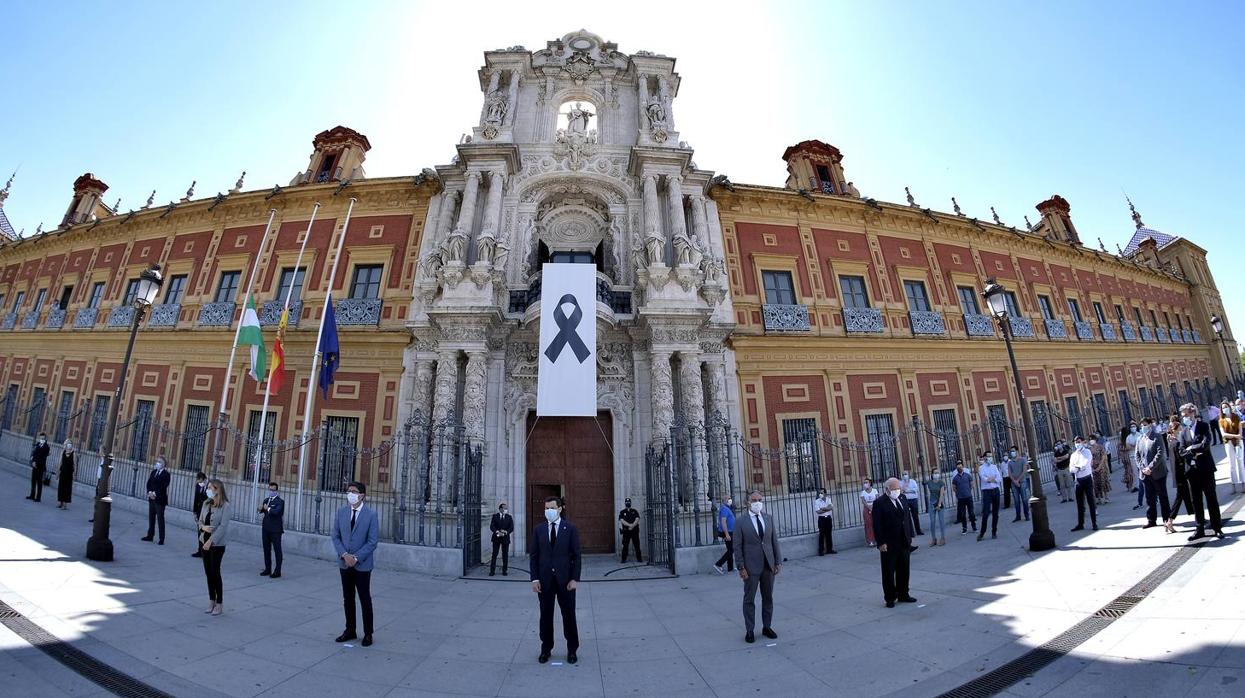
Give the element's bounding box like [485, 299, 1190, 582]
[525, 412, 618, 554]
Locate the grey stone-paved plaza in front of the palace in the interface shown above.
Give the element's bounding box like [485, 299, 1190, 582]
[0, 449, 1245, 697]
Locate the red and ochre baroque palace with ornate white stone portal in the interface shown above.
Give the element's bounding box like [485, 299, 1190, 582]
[0, 31, 1235, 551]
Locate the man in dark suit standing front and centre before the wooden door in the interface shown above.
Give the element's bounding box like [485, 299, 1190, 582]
[528, 496, 581, 664]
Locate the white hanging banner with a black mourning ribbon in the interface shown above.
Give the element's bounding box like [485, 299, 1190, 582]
[537, 264, 596, 417]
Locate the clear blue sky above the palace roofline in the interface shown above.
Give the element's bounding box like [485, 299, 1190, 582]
[0, 0, 1245, 345]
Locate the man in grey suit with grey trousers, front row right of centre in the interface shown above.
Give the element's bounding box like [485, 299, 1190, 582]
[731, 490, 782, 642]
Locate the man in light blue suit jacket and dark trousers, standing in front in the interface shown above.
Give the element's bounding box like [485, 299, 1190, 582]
[332, 483, 380, 647]
